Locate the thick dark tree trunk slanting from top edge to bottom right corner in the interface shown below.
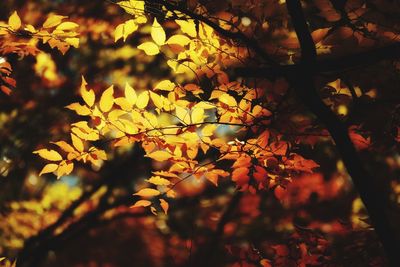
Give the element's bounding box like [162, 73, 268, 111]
[286, 0, 400, 266]
